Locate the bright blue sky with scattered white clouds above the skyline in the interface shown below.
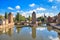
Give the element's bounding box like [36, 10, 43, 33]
[0, 0, 60, 17]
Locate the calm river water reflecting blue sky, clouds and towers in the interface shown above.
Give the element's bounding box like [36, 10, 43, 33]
[0, 26, 60, 40]
